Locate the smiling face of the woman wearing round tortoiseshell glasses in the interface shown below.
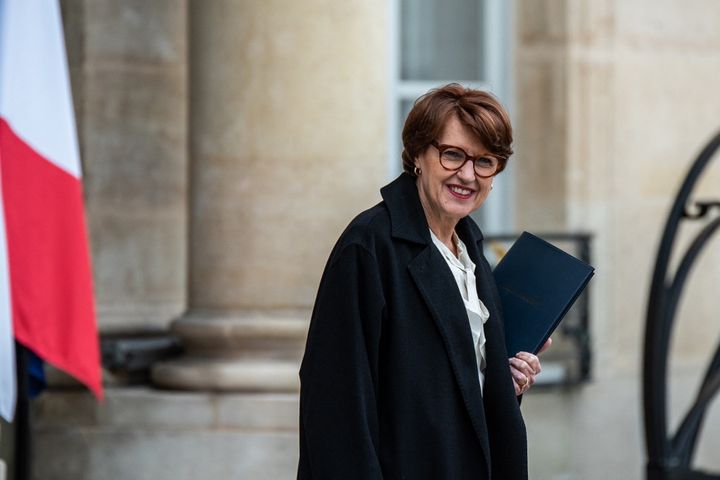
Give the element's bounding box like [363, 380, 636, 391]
[415, 115, 492, 228]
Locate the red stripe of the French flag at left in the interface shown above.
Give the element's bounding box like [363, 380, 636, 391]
[0, 118, 103, 398]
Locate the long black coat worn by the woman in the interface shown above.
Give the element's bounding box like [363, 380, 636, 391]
[298, 174, 527, 480]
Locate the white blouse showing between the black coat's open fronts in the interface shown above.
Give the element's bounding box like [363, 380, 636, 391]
[430, 230, 490, 394]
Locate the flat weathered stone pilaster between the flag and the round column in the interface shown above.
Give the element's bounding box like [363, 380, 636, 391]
[61, 0, 188, 334]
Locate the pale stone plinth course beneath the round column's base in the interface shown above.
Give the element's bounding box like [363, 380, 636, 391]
[32, 387, 298, 480]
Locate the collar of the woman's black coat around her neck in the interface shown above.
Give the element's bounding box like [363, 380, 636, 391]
[380, 173, 483, 245]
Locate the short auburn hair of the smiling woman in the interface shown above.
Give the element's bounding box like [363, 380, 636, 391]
[402, 83, 513, 175]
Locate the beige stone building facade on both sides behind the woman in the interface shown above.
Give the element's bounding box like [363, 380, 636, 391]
[29, 0, 720, 480]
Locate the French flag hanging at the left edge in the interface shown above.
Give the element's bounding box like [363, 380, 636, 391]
[0, 0, 103, 420]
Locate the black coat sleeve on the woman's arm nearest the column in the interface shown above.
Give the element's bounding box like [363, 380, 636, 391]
[298, 244, 385, 480]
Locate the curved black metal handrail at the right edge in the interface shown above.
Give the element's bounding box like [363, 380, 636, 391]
[643, 129, 720, 480]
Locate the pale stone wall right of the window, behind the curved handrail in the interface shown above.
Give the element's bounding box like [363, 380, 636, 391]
[516, 0, 720, 479]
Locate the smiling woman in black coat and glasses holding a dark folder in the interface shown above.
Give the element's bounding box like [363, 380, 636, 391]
[298, 84, 540, 480]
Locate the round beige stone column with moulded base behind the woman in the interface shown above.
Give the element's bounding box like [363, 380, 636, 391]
[153, 0, 386, 391]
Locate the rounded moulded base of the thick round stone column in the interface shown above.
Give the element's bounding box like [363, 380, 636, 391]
[152, 311, 310, 392]
